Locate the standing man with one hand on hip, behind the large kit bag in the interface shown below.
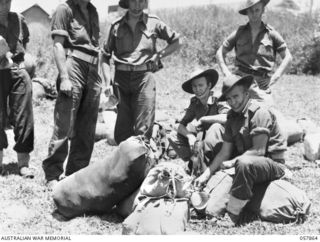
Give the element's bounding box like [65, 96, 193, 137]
[102, 0, 179, 144]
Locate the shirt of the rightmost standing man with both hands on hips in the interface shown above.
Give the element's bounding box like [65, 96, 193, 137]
[223, 23, 287, 73]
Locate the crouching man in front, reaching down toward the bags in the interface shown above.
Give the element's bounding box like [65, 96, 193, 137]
[195, 76, 286, 224]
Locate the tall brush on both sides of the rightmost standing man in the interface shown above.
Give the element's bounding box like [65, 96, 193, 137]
[151, 5, 320, 74]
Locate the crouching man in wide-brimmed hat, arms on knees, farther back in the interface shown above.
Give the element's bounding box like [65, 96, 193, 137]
[169, 69, 229, 173]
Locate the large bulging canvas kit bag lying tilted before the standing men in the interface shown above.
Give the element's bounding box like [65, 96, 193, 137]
[53, 137, 154, 218]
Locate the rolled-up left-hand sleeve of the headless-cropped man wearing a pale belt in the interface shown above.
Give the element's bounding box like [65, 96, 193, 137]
[51, 4, 71, 38]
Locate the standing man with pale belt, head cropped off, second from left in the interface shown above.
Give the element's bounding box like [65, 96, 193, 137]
[43, 0, 101, 188]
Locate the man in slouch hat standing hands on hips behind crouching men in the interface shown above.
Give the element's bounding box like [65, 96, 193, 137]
[217, 0, 292, 105]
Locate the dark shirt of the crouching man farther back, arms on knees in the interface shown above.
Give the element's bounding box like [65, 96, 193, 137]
[180, 96, 230, 130]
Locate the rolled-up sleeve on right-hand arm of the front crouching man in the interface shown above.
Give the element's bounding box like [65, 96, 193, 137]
[250, 109, 274, 136]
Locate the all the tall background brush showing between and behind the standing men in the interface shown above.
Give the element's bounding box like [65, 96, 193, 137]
[28, 5, 320, 79]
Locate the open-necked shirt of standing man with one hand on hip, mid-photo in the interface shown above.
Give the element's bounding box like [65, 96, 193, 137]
[103, 12, 179, 65]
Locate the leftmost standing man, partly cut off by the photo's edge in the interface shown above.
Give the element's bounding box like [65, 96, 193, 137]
[0, 0, 34, 178]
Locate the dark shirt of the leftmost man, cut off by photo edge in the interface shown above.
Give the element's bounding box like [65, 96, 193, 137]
[0, 12, 30, 62]
